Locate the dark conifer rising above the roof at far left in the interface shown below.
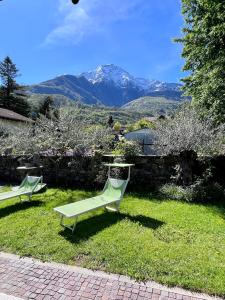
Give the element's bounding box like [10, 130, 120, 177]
[0, 56, 30, 116]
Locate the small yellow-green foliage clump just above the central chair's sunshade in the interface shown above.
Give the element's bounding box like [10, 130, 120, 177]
[113, 139, 141, 158]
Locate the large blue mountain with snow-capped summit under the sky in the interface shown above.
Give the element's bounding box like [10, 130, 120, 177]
[30, 64, 185, 107]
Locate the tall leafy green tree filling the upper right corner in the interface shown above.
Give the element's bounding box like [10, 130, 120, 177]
[176, 0, 225, 123]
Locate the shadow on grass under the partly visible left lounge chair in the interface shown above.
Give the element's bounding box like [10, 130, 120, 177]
[0, 200, 43, 219]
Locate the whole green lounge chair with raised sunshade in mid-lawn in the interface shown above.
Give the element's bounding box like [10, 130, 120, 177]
[54, 163, 133, 232]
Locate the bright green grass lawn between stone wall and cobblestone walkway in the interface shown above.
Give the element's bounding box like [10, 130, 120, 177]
[0, 189, 225, 296]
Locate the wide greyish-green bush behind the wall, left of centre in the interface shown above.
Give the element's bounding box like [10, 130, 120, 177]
[0, 109, 111, 155]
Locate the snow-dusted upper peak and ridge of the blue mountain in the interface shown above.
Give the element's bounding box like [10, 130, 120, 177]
[80, 64, 180, 92]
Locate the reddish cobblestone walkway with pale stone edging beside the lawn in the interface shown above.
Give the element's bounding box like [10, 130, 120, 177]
[0, 253, 219, 300]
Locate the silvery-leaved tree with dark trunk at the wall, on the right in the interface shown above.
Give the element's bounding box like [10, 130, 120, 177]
[155, 105, 224, 185]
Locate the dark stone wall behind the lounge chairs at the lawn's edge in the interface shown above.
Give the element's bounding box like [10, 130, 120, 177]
[0, 155, 225, 191]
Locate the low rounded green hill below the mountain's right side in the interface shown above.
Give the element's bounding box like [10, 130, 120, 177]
[122, 96, 185, 115]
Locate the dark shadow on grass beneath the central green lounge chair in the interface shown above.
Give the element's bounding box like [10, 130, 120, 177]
[60, 212, 165, 243]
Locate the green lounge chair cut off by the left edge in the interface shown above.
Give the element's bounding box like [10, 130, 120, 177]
[0, 176, 42, 201]
